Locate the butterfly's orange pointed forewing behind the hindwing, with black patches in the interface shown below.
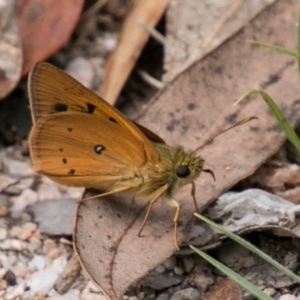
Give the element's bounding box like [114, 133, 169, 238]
[28, 63, 159, 162]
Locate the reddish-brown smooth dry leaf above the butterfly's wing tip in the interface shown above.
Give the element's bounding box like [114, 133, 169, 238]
[18, 0, 84, 75]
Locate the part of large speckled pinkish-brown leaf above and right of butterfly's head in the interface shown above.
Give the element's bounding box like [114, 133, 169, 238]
[139, 0, 300, 210]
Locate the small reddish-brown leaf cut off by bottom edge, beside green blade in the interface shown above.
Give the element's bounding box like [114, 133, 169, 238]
[202, 278, 242, 300]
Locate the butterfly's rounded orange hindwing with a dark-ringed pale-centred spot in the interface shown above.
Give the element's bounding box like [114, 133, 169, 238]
[29, 112, 146, 190]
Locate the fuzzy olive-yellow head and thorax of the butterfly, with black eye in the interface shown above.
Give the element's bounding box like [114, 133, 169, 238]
[137, 142, 204, 198]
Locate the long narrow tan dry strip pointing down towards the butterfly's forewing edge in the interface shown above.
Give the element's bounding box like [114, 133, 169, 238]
[100, 0, 170, 104]
